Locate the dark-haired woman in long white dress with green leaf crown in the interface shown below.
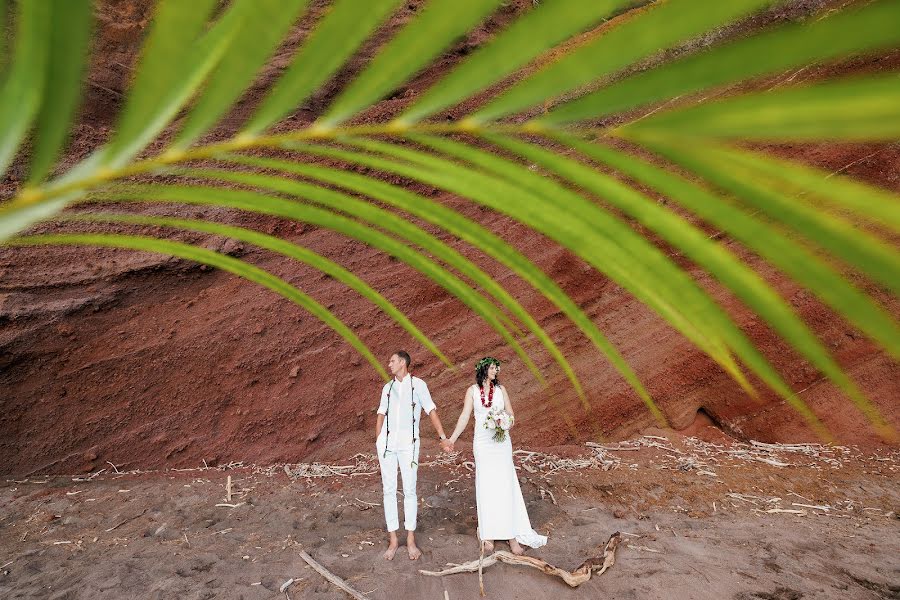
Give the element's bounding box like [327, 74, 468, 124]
[445, 356, 547, 554]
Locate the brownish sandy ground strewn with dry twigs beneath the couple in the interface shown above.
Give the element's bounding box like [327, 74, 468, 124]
[0, 435, 900, 600]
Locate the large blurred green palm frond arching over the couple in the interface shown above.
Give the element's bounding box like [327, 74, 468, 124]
[0, 0, 900, 438]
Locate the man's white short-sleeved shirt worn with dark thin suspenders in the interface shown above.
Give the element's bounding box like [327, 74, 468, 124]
[377, 373, 437, 453]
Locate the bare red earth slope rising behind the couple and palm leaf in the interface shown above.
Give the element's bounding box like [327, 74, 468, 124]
[0, 0, 900, 475]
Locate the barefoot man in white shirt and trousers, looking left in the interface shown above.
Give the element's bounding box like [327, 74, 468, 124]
[375, 350, 449, 560]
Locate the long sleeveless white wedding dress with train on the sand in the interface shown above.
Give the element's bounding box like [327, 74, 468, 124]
[472, 385, 547, 548]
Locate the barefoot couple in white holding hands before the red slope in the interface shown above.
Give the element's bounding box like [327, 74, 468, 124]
[375, 350, 547, 560]
